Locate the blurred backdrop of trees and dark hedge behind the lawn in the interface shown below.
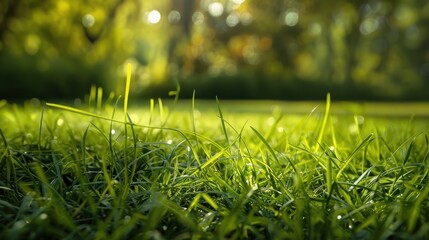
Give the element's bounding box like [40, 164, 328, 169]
[0, 0, 429, 101]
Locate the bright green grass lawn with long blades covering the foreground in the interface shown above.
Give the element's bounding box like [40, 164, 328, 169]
[0, 85, 429, 239]
